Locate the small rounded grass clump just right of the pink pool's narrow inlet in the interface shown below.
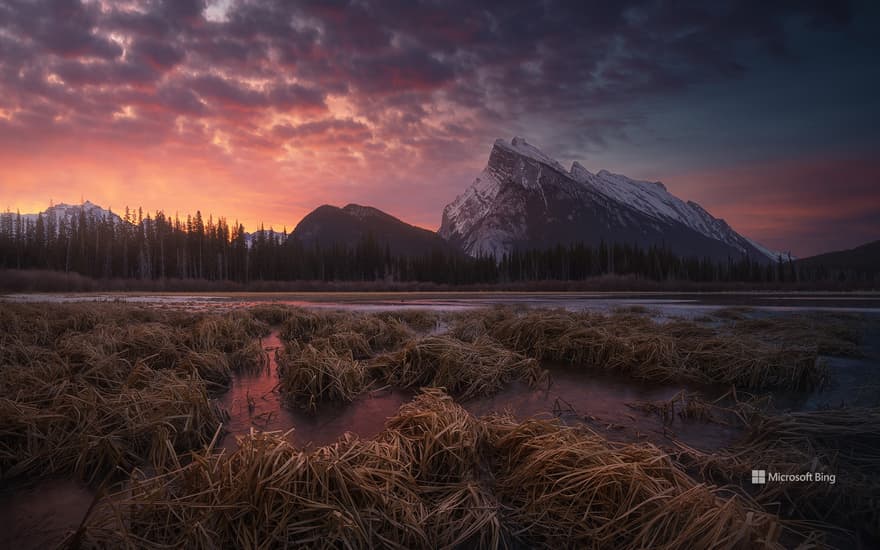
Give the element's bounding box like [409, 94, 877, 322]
[276, 344, 367, 410]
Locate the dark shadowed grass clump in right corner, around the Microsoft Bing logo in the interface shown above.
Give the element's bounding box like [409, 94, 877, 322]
[685, 408, 880, 543]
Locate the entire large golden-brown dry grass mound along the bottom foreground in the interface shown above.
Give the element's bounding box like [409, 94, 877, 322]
[77, 390, 792, 549]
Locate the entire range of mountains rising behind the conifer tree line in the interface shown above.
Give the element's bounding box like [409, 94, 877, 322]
[13, 137, 868, 266]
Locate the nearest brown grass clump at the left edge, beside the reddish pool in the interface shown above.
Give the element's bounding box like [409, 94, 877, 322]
[0, 364, 219, 481]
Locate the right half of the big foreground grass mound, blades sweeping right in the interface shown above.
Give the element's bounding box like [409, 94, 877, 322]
[490, 419, 781, 549]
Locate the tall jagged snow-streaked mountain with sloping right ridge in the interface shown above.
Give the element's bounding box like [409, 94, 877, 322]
[439, 137, 777, 261]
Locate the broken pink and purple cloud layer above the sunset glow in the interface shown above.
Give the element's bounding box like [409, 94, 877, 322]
[0, 0, 864, 254]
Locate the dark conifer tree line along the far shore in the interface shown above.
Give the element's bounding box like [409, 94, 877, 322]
[0, 208, 878, 285]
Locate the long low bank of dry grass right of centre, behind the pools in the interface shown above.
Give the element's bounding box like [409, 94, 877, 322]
[488, 311, 826, 389]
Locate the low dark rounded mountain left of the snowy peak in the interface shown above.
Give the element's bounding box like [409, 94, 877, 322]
[290, 204, 454, 256]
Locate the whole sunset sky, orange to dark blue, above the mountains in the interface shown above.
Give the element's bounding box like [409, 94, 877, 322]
[0, 0, 880, 256]
